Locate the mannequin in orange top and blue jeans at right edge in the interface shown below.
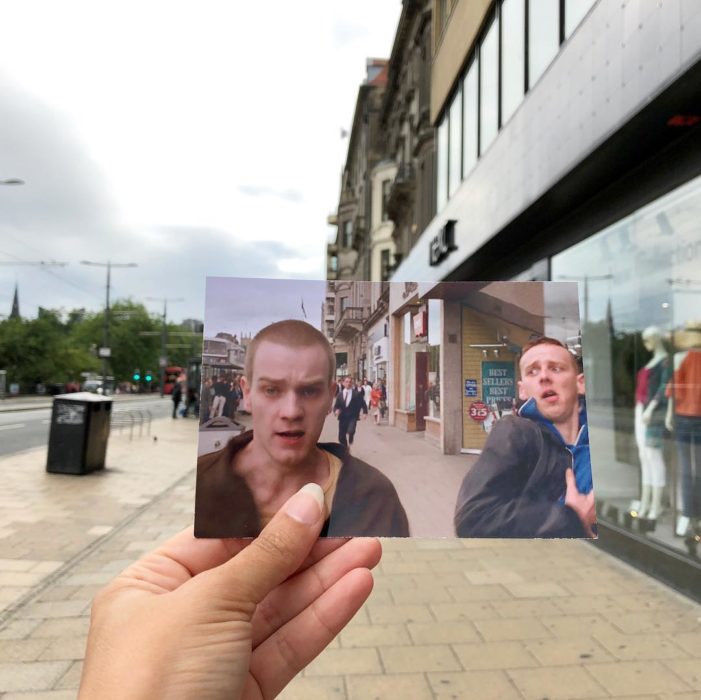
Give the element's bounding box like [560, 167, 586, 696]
[665, 323, 701, 539]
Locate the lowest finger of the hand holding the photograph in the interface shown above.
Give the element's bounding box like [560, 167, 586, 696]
[250, 569, 372, 698]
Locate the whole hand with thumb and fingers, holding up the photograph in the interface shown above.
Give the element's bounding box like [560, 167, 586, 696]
[78, 484, 381, 700]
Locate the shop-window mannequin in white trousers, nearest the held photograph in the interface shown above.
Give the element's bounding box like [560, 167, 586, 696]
[632, 326, 670, 520]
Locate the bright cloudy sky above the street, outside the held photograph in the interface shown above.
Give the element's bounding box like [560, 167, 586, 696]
[0, 0, 401, 320]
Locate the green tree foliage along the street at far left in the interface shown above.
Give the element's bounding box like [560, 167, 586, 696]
[0, 300, 202, 391]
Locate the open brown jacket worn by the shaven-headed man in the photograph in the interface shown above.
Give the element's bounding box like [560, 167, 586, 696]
[195, 430, 409, 537]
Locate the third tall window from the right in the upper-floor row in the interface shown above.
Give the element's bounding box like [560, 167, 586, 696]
[501, 0, 526, 124]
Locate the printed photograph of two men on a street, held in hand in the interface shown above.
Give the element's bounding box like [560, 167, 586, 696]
[195, 277, 596, 538]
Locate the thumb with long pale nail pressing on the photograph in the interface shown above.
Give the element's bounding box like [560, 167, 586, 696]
[209, 483, 324, 605]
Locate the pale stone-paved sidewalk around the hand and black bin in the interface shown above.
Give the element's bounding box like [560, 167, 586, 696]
[0, 420, 701, 700]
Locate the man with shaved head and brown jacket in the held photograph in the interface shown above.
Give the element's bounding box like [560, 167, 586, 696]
[195, 320, 409, 537]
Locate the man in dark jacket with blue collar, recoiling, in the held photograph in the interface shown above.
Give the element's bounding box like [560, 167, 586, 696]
[455, 337, 596, 537]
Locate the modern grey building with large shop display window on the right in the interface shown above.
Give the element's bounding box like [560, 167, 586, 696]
[392, 0, 701, 594]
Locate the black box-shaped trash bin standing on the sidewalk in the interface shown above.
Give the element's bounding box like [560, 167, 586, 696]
[46, 391, 112, 474]
